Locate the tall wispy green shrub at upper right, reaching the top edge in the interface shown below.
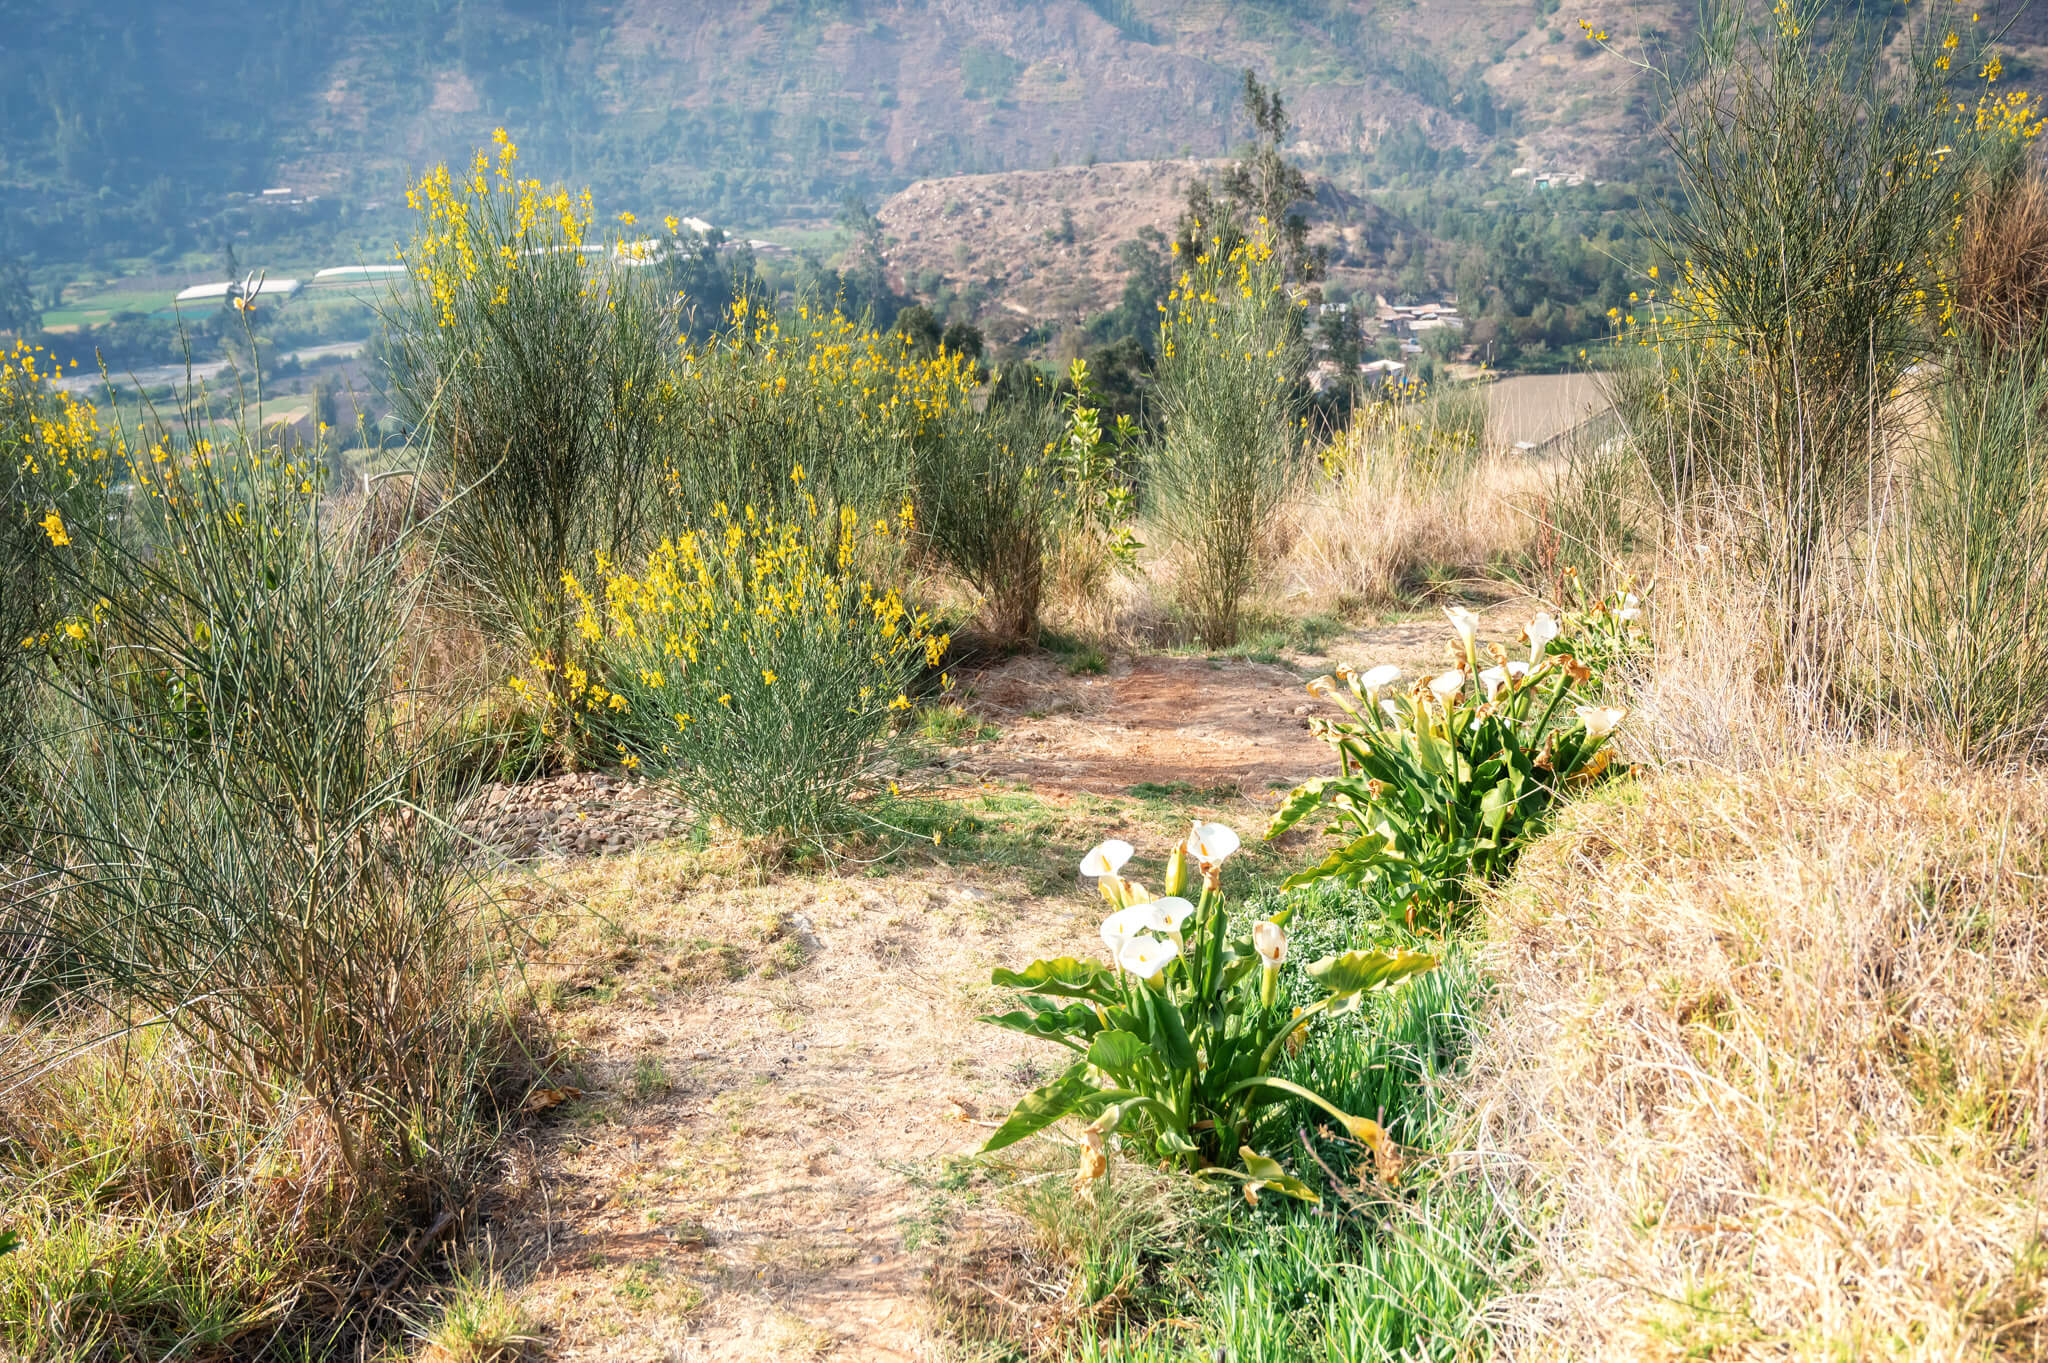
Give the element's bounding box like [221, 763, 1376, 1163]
[1616, 4, 1970, 692]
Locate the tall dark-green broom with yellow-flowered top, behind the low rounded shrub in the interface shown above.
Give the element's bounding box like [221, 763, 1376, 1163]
[387, 131, 676, 736]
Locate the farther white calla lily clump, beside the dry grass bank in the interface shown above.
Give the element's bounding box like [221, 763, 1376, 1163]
[1266, 593, 1640, 927]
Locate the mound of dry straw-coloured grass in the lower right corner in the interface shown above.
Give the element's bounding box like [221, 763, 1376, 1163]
[1477, 753, 2048, 1359]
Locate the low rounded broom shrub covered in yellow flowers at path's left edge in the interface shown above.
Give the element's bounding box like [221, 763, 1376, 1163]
[571, 508, 946, 841]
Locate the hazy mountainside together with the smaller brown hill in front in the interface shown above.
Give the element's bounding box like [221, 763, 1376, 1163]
[0, 0, 2048, 376]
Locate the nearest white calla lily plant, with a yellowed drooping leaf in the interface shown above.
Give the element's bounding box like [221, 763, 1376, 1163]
[983, 823, 1436, 1201]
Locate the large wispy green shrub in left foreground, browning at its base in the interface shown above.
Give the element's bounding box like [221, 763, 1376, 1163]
[0, 427, 505, 1191]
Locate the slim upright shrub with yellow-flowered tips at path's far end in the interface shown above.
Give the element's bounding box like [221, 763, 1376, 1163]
[1147, 224, 1305, 647]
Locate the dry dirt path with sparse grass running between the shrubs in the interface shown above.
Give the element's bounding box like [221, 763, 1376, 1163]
[483, 624, 1523, 1363]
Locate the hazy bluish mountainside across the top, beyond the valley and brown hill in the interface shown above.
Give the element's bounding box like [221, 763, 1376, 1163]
[32, 0, 2048, 254]
